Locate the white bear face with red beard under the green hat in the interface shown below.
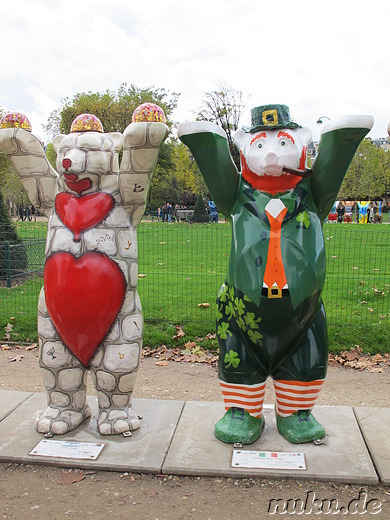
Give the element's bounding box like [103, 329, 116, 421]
[234, 128, 311, 194]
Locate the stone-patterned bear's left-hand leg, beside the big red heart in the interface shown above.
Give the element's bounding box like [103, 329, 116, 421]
[35, 289, 91, 435]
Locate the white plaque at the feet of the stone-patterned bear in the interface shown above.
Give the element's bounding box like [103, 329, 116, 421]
[29, 439, 105, 460]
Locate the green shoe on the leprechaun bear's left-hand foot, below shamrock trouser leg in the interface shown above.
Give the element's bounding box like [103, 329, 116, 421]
[214, 407, 264, 444]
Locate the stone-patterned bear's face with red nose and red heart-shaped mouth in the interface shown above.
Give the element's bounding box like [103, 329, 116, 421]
[53, 132, 123, 195]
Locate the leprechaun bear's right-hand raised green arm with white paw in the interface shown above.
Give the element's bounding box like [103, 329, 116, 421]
[310, 116, 374, 219]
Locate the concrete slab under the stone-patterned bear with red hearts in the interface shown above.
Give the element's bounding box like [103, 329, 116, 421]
[0, 393, 184, 473]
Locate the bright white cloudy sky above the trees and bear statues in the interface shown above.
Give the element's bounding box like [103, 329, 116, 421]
[0, 0, 390, 138]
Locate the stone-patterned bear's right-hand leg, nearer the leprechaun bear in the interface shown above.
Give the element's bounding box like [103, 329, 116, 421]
[90, 342, 141, 435]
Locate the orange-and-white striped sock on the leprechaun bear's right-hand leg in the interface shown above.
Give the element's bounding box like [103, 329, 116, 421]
[274, 379, 325, 417]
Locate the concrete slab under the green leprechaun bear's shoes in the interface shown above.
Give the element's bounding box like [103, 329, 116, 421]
[163, 401, 378, 484]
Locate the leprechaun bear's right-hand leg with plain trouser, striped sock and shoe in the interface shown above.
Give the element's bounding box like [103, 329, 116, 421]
[273, 305, 328, 444]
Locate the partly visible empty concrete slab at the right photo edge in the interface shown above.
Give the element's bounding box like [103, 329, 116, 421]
[354, 406, 390, 486]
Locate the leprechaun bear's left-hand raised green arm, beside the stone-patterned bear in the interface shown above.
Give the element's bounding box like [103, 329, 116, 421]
[177, 121, 239, 217]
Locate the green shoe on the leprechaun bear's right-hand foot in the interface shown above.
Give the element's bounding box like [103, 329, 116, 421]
[276, 410, 326, 444]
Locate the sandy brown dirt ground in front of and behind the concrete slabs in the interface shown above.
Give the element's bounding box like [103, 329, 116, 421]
[0, 348, 390, 520]
